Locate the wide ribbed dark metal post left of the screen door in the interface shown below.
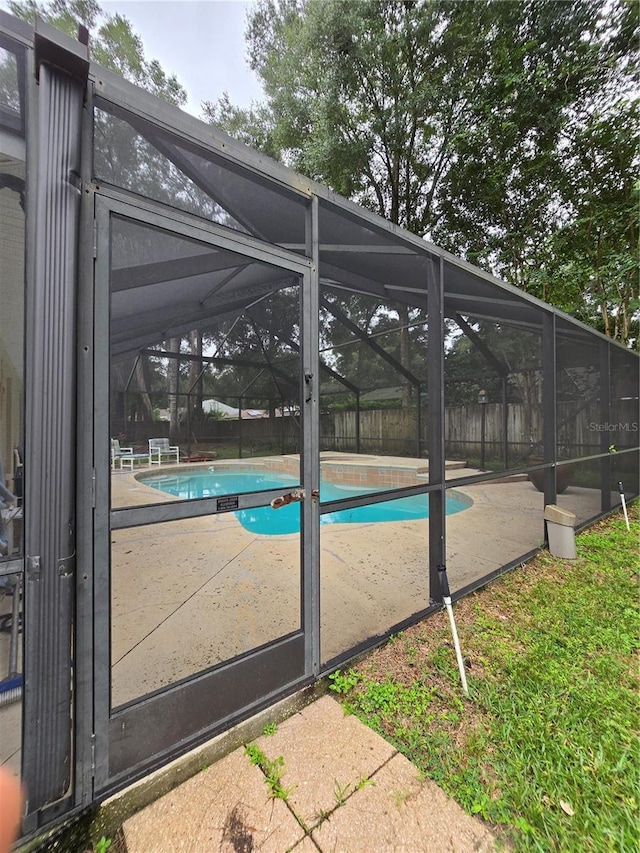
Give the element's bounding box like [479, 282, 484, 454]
[22, 28, 89, 820]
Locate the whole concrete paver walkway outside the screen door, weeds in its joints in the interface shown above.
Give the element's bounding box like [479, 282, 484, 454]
[123, 696, 495, 853]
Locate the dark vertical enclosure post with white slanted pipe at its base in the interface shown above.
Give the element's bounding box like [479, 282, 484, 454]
[427, 258, 446, 602]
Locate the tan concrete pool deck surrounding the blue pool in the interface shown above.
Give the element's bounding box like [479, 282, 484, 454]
[106, 453, 599, 706]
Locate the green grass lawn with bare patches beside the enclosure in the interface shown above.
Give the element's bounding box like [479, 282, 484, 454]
[331, 501, 640, 853]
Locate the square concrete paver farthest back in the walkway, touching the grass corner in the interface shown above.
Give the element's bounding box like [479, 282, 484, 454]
[257, 696, 396, 828]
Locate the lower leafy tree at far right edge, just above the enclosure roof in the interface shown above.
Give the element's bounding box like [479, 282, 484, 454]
[536, 101, 640, 348]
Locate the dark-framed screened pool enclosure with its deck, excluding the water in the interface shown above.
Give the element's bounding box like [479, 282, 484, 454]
[0, 12, 640, 838]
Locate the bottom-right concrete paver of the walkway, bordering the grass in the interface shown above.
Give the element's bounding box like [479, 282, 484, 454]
[312, 753, 495, 853]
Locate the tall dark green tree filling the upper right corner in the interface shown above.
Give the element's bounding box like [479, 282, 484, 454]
[434, 2, 638, 343]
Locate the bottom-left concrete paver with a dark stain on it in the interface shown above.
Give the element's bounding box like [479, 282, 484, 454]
[123, 749, 308, 853]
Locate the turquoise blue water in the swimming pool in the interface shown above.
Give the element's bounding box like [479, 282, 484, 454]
[140, 469, 470, 536]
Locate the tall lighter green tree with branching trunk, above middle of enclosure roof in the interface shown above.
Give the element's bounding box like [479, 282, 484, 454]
[230, 0, 490, 233]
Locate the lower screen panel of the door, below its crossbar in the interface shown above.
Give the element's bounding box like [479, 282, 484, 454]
[111, 507, 301, 708]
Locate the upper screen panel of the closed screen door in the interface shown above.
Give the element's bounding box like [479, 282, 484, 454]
[110, 216, 301, 507]
